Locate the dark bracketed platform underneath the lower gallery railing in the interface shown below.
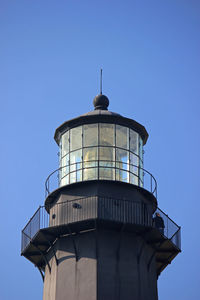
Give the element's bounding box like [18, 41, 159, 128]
[21, 219, 181, 276]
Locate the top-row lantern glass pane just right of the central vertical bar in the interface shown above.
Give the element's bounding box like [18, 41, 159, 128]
[99, 123, 115, 146]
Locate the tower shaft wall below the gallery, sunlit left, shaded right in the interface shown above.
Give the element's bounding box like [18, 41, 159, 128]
[43, 230, 157, 300]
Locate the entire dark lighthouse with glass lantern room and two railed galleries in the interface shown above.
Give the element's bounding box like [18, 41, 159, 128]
[21, 94, 180, 300]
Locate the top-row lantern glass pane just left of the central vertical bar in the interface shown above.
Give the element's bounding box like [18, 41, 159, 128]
[83, 124, 98, 147]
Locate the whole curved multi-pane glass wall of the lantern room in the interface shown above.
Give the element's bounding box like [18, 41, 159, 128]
[59, 123, 143, 186]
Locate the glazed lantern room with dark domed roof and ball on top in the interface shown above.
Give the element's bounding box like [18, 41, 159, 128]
[55, 94, 148, 187]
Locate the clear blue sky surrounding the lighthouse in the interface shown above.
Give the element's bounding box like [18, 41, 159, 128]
[0, 0, 200, 300]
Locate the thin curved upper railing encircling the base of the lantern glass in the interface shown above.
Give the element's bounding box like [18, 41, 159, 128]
[45, 160, 157, 198]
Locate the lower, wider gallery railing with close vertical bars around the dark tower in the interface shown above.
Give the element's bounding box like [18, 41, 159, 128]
[21, 196, 181, 252]
